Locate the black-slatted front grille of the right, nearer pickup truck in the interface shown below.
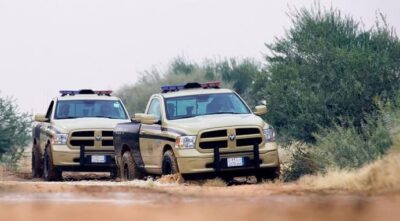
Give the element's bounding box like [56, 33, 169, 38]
[199, 127, 263, 149]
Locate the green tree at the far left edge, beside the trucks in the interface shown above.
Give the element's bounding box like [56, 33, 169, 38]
[0, 94, 32, 163]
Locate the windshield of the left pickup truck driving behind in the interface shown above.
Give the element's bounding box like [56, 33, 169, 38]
[54, 100, 127, 119]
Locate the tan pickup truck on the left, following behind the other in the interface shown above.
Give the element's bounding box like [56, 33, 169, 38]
[32, 89, 130, 181]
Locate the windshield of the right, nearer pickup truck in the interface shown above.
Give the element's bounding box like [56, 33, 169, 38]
[165, 93, 250, 120]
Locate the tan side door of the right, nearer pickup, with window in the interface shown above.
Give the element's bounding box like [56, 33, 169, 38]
[139, 97, 161, 172]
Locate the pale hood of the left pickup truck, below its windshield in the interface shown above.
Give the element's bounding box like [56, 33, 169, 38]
[52, 118, 130, 133]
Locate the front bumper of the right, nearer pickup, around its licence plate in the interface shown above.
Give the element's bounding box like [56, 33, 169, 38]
[177, 144, 279, 174]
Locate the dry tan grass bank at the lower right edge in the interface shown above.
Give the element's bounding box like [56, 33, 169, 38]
[299, 150, 400, 192]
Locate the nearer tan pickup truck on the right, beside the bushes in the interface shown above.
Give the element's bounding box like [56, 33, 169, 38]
[114, 82, 280, 181]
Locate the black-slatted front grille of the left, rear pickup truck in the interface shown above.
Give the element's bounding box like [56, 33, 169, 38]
[68, 130, 114, 147]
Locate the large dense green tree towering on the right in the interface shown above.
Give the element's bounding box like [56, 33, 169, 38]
[253, 6, 400, 142]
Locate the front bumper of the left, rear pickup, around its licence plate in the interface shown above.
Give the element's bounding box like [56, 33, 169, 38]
[52, 145, 116, 172]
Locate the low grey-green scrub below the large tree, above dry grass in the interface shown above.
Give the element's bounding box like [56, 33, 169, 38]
[283, 105, 394, 181]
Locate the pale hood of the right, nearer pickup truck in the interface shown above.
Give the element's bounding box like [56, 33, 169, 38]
[168, 114, 268, 135]
